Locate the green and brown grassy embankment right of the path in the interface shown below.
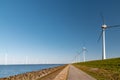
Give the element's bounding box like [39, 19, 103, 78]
[73, 58, 120, 80]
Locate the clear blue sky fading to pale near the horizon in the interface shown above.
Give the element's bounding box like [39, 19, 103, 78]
[0, 0, 120, 64]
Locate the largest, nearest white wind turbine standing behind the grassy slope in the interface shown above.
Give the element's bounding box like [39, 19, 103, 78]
[98, 15, 120, 60]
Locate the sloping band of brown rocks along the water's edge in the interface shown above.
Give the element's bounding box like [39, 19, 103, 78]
[0, 65, 66, 80]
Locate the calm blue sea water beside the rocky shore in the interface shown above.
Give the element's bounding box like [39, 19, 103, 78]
[0, 64, 62, 78]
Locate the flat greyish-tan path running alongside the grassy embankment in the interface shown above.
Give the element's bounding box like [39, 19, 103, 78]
[67, 65, 96, 80]
